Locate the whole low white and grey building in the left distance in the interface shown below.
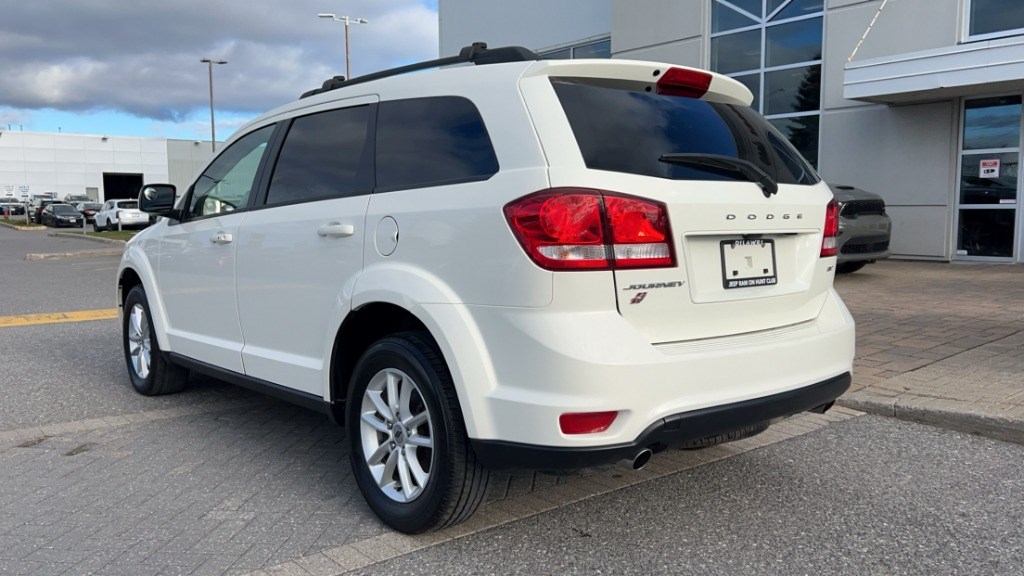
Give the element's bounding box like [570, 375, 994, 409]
[0, 130, 211, 202]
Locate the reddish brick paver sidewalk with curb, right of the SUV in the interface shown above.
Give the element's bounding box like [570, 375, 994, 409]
[836, 260, 1024, 443]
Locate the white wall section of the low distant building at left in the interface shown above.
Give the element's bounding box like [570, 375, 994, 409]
[0, 130, 168, 200]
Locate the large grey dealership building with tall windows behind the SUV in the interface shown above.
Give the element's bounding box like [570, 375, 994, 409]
[439, 0, 1024, 262]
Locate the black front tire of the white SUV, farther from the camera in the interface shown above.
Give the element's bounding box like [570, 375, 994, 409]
[121, 285, 188, 396]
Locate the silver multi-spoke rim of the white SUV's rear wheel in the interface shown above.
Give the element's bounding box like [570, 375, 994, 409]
[359, 368, 434, 502]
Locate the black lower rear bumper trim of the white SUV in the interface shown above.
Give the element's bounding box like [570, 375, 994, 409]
[470, 372, 850, 470]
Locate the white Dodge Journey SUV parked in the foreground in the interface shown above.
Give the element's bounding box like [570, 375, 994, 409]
[118, 44, 854, 532]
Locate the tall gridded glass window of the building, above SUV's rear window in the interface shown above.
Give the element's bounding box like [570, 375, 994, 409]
[711, 0, 824, 166]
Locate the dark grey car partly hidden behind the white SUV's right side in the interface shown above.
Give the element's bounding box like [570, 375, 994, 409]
[828, 183, 892, 274]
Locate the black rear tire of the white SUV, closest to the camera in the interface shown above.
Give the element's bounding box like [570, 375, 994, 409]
[345, 332, 489, 534]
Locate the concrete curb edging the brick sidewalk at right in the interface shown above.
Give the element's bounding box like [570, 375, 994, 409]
[838, 389, 1024, 444]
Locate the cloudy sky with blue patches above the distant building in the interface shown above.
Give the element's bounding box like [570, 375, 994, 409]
[0, 0, 437, 139]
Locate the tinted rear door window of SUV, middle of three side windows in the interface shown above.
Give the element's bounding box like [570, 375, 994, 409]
[266, 106, 373, 204]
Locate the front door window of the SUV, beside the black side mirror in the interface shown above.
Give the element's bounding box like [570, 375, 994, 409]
[188, 125, 273, 217]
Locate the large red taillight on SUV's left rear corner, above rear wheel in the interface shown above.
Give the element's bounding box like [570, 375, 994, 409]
[505, 188, 676, 270]
